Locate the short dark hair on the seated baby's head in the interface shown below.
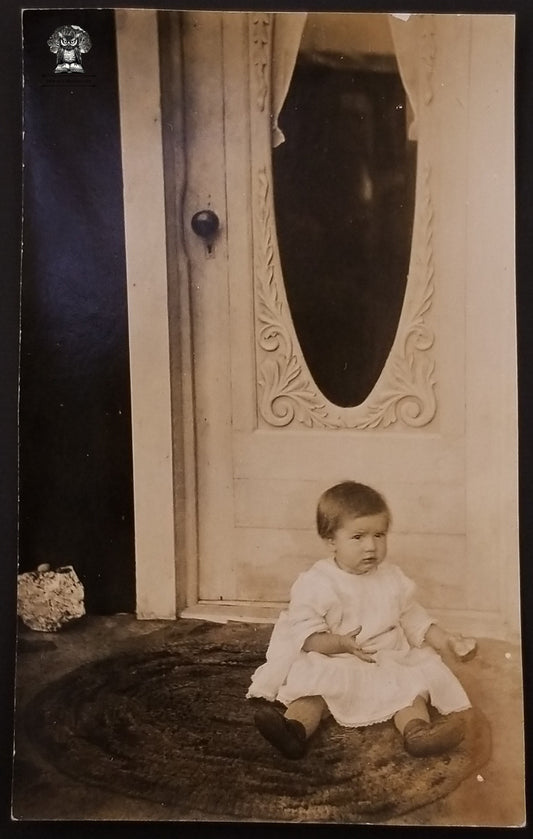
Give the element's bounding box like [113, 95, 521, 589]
[316, 481, 391, 539]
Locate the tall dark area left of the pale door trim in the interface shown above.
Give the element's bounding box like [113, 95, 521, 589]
[19, 9, 135, 614]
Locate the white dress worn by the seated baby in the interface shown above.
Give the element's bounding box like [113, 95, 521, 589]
[247, 558, 470, 727]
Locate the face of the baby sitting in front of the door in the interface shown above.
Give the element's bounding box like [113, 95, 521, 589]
[327, 513, 388, 574]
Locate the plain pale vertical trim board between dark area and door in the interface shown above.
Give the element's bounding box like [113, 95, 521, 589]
[115, 9, 177, 619]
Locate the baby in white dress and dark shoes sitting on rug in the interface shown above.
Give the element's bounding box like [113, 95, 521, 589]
[247, 481, 476, 758]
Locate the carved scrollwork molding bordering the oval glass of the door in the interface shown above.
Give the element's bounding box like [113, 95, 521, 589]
[252, 15, 437, 429]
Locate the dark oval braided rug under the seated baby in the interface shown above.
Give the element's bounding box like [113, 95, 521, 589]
[25, 638, 490, 822]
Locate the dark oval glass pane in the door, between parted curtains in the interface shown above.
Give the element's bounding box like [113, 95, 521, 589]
[273, 13, 416, 407]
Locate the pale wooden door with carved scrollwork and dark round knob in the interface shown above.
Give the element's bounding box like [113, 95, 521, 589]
[178, 12, 517, 631]
